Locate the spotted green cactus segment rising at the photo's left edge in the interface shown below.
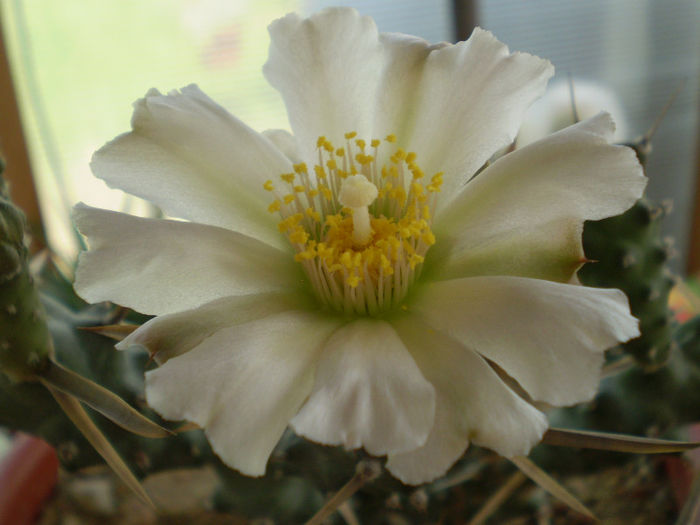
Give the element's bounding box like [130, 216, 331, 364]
[0, 175, 52, 381]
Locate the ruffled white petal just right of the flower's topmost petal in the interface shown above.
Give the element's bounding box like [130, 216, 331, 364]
[408, 28, 554, 205]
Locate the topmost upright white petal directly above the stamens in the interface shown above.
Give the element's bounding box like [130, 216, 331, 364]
[263, 8, 382, 162]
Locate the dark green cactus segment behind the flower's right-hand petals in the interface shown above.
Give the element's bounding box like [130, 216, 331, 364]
[578, 199, 674, 370]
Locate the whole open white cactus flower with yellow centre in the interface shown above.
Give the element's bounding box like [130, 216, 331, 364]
[75, 8, 645, 484]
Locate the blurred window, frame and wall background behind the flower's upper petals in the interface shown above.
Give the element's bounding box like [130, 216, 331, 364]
[0, 0, 700, 272]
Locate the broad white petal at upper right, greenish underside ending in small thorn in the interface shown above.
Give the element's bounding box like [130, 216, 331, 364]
[431, 114, 646, 282]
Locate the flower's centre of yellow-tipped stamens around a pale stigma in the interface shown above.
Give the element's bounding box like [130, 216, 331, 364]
[264, 132, 442, 315]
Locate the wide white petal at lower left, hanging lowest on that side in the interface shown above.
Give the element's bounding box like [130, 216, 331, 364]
[146, 311, 338, 476]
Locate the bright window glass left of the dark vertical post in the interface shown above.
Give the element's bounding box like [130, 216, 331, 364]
[1, 0, 452, 258]
